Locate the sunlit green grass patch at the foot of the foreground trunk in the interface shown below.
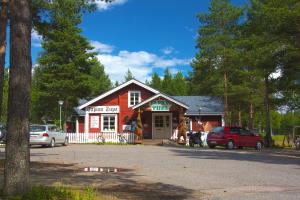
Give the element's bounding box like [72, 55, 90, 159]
[0, 185, 117, 200]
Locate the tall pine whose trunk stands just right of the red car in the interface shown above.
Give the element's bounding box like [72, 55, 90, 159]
[245, 0, 294, 146]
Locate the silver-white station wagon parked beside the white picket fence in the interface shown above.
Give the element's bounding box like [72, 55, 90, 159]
[30, 124, 69, 147]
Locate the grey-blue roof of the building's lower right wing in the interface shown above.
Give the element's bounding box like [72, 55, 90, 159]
[173, 96, 224, 115]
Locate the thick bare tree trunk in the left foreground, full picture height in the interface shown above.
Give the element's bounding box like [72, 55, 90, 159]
[4, 0, 31, 195]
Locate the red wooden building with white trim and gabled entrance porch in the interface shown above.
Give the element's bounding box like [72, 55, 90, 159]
[76, 79, 223, 139]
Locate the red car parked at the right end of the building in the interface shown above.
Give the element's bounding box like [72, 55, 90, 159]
[207, 126, 263, 150]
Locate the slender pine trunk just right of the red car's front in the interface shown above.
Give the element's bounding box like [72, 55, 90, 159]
[264, 75, 272, 147]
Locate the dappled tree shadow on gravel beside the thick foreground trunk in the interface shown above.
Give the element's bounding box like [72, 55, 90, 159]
[0, 160, 203, 200]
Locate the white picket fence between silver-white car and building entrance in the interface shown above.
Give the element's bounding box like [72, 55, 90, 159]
[67, 133, 134, 144]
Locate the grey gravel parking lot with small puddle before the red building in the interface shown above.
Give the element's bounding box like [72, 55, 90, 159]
[2, 145, 300, 199]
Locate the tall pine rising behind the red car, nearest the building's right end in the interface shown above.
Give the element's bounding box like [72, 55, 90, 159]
[192, 0, 242, 124]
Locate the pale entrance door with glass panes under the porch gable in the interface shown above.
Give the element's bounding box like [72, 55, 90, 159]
[152, 113, 172, 139]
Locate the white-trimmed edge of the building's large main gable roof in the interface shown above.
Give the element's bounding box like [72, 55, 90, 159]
[77, 79, 159, 110]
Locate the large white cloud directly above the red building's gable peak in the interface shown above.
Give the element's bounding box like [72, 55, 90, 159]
[98, 50, 191, 82]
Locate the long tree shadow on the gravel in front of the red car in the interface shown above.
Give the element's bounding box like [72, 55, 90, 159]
[170, 148, 300, 165]
